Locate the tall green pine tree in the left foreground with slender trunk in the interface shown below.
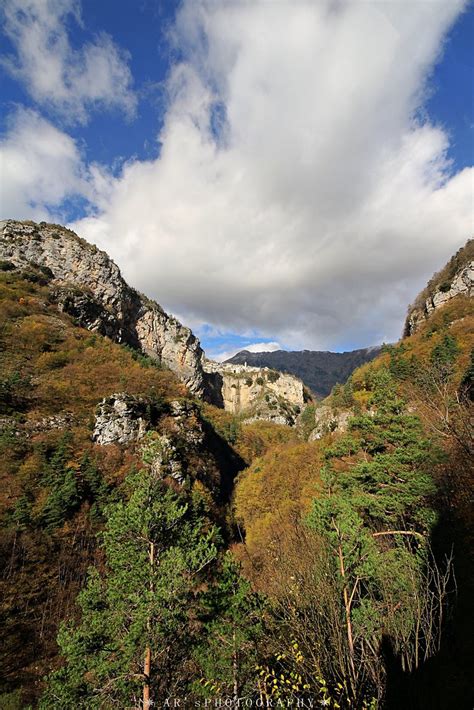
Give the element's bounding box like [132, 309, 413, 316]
[41, 470, 217, 710]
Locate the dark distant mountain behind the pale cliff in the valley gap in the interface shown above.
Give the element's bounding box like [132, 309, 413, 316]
[226, 347, 381, 397]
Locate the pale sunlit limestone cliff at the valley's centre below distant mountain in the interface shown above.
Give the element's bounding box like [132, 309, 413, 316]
[204, 360, 304, 426]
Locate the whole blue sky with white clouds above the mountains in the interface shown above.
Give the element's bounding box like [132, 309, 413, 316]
[0, 0, 474, 356]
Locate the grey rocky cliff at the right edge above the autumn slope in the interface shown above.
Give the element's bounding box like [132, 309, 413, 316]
[403, 239, 474, 337]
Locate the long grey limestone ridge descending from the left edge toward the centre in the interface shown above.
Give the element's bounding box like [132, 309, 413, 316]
[0, 220, 204, 395]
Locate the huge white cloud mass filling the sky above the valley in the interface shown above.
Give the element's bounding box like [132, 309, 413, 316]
[4, 0, 473, 349]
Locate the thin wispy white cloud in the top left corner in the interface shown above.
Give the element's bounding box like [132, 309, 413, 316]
[2, 0, 136, 123]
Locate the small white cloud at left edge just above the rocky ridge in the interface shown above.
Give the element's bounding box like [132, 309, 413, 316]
[0, 108, 89, 220]
